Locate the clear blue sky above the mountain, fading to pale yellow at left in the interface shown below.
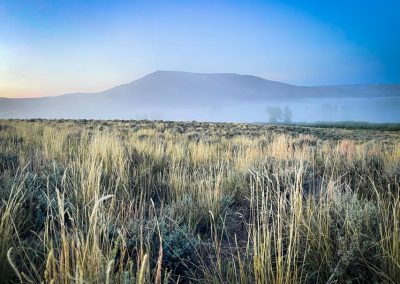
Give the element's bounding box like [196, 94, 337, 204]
[0, 0, 400, 97]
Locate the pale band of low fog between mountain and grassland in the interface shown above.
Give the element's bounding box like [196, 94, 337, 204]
[0, 97, 400, 122]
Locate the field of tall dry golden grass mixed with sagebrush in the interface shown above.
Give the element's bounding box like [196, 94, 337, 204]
[0, 120, 400, 283]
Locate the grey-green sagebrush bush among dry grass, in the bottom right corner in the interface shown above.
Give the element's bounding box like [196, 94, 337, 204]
[324, 191, 382, 283]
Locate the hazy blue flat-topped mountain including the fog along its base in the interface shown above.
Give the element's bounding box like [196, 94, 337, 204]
[0, 71, 400, 121]
